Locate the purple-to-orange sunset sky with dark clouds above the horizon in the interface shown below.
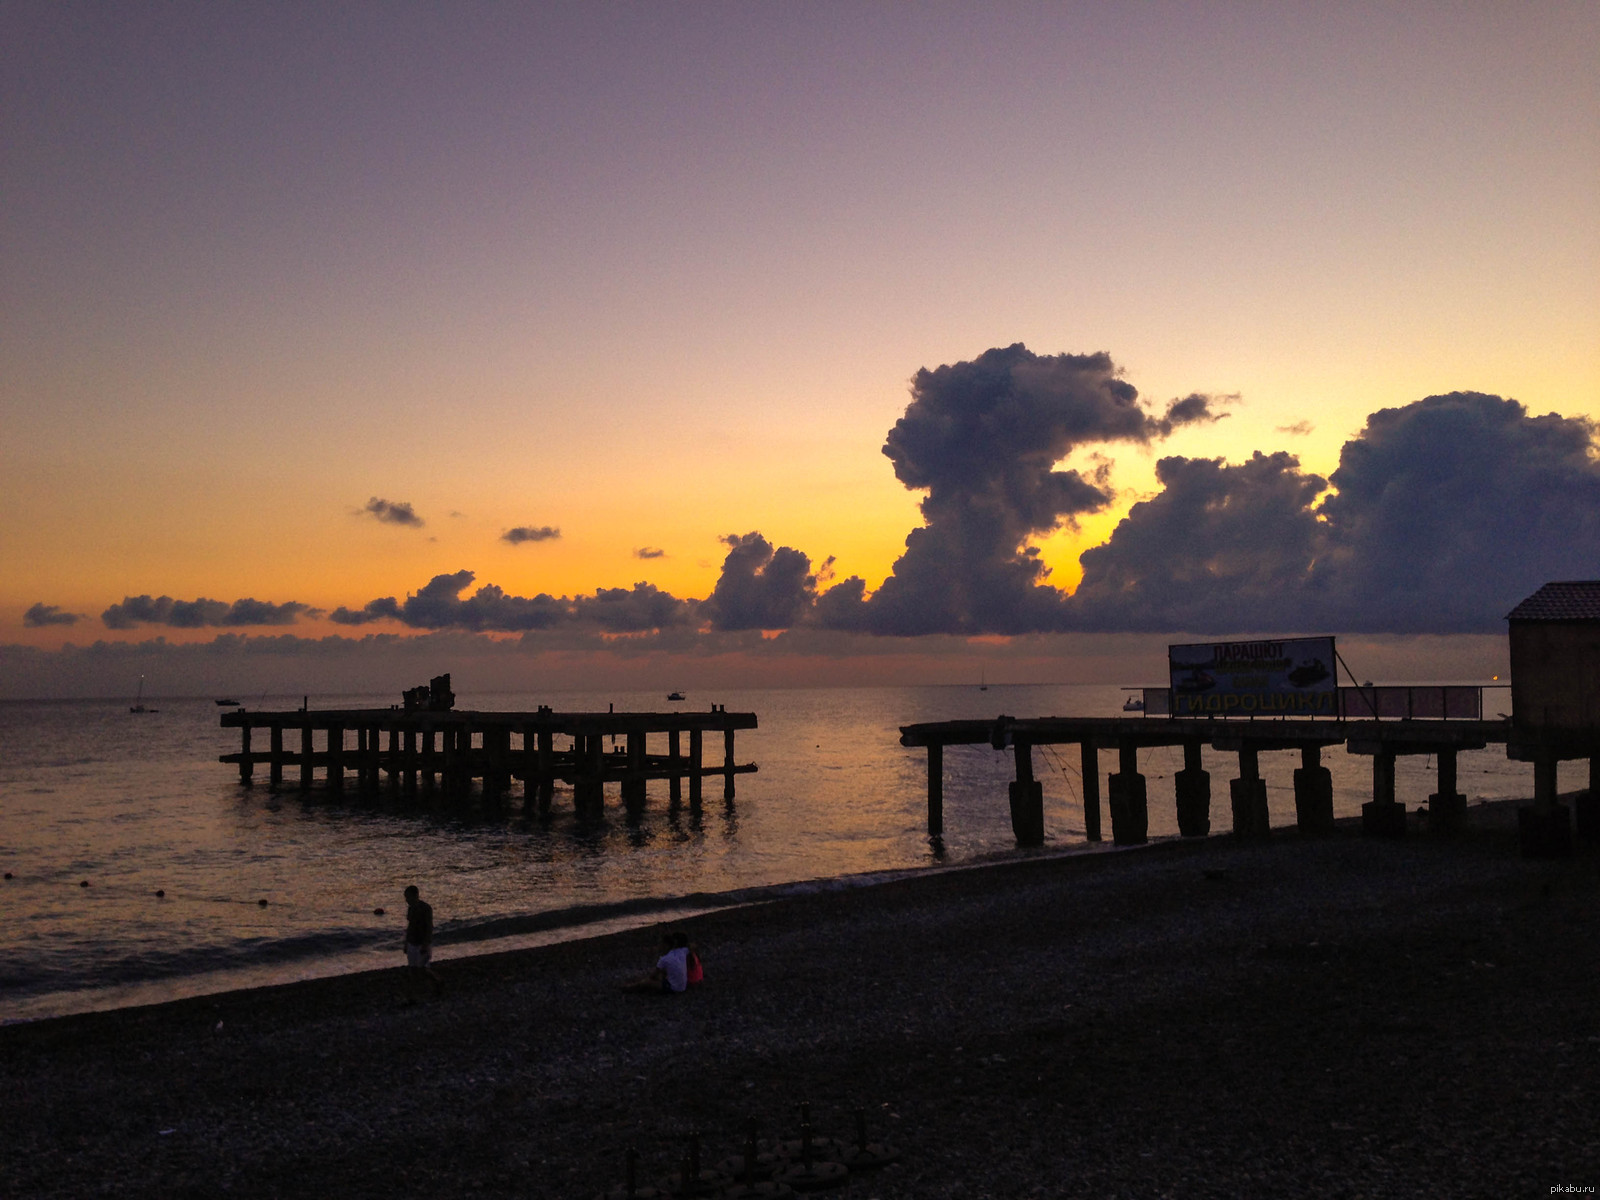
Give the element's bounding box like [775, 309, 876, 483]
[0, 0, 1600, 694]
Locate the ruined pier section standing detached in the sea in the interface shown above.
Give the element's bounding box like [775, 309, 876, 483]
[221, 710, 757, 819]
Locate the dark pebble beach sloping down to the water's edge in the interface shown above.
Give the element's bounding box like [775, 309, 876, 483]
[0, 803, 1600, 1200]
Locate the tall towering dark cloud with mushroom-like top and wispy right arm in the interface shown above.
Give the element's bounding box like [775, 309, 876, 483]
[851, 342, 1221, 635]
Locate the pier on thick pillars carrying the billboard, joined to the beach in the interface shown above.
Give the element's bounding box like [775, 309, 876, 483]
[901, 715, 1510, 846]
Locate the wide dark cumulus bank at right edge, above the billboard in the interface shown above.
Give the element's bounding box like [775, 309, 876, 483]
[1070, 392, 1600, 634]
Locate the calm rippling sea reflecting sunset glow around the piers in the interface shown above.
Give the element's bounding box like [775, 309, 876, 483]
[0, 685, 1555, 1021]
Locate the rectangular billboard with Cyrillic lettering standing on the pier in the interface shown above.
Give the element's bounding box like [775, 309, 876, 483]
[1166, 637, 1339, 717]
